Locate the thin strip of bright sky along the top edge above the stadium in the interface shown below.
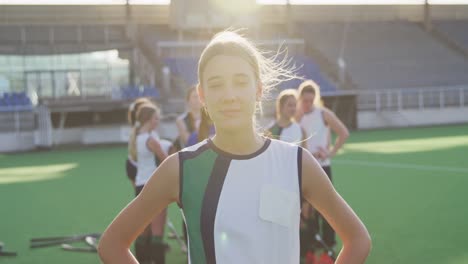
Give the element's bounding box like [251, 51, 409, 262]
[0, 0, 468, 5]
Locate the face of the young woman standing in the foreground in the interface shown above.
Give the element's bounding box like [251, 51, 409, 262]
[199, 55, 261, 130]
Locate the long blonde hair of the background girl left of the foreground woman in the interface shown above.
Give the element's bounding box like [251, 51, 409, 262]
[128, 103, 160, 161]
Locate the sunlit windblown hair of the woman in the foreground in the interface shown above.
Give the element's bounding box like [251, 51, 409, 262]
[198, 30, 298, 116]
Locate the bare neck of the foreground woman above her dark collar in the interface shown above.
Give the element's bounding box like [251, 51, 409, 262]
[213, 124, 264, 155]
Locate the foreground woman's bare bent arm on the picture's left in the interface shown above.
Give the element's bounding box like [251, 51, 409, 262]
[98, 154, 179, 264]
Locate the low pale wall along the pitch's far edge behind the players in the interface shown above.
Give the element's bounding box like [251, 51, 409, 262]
[0, 107, 468, 152]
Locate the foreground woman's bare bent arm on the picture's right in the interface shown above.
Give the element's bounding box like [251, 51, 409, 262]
[302, 150, 371, 264]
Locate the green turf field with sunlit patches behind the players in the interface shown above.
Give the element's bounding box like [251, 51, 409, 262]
[0, 125, 468, 264]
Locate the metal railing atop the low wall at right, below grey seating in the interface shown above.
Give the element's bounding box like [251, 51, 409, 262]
[356, 85, 468, 112]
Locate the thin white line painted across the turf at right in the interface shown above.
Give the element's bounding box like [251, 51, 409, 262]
[333, 159, 468, 173]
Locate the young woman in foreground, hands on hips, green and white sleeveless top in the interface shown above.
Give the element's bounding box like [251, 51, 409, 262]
[99, 32, 371, 264]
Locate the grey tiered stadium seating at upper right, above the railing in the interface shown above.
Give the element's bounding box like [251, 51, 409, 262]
[300, 21, 468, 89]
